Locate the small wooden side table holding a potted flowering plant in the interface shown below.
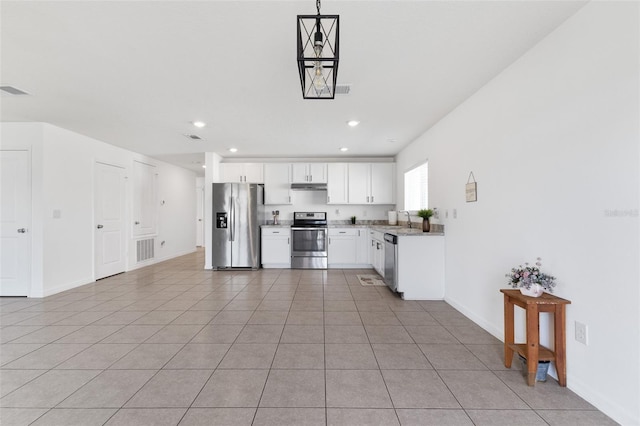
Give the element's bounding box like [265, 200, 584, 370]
[500, 289, 571, 386]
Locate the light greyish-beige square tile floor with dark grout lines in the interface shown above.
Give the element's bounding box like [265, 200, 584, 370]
[0, 251, 615, 426]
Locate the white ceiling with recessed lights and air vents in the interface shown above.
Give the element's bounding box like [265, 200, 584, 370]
[0, 0, 585, 176]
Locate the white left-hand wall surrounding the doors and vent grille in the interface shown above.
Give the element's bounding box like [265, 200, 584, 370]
[0, 123, 195, 297]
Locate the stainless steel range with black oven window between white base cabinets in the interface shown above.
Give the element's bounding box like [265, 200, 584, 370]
[291, 212, 328, 269]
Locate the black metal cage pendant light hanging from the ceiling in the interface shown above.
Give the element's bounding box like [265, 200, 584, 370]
[297, 0, 340, 99]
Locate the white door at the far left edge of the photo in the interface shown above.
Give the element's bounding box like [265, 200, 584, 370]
[0, 151, 31, 296]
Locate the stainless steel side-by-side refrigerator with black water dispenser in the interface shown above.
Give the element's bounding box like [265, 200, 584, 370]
[212, 183, 264, 270]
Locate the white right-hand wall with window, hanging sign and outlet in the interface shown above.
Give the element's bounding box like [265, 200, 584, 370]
[397, 2, 640, 425]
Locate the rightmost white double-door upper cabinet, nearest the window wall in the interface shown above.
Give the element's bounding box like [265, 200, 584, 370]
[349, 163, 395, 204]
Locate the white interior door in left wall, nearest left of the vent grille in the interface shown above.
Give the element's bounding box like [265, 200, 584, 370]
[94, 163, 125, 280]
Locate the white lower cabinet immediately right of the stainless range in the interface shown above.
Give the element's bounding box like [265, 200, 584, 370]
[327, 228, 369, 268]
